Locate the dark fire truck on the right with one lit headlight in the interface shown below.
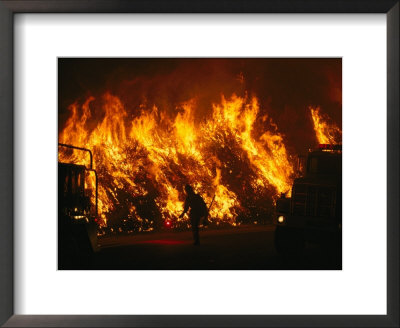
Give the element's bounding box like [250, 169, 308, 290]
[274, 144, 342, 254]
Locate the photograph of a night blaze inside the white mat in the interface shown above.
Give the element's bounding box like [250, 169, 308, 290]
[57, 57, 342, 270]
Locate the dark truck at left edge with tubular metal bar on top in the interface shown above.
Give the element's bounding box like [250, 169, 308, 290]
[58, 143, 99, 269]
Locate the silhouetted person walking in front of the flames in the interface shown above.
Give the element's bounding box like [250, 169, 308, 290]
[179, 184, 208, 245]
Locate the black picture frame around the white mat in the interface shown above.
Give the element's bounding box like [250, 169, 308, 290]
[0, 0, 400, 327]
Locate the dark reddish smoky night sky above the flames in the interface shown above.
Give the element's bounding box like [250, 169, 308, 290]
[58, 58, 342, 153]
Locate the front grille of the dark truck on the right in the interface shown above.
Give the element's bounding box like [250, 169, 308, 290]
[292, 185, 335, 217]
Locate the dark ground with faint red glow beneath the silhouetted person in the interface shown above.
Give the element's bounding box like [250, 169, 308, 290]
[76, 225, 341, 270]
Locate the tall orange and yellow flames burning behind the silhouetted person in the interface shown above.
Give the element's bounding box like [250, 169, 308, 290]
[59, 93, 336, 231]
